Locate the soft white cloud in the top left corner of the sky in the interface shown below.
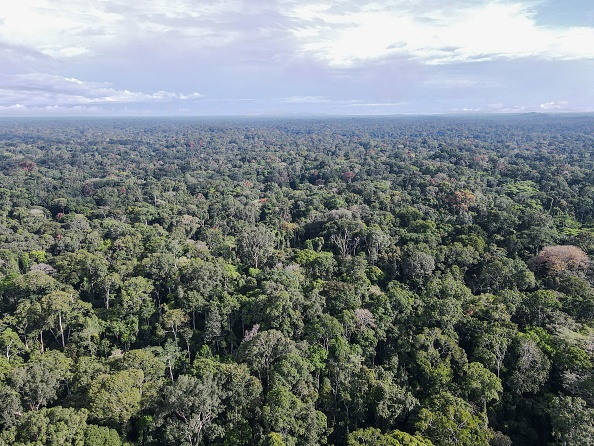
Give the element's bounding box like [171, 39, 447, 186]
[0, 0, 276, 60]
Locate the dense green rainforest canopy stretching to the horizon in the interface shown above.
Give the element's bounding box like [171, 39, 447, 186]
[0, 114, 594, 446]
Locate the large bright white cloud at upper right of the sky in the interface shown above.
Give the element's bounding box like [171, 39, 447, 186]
[295, 1, 594, 66]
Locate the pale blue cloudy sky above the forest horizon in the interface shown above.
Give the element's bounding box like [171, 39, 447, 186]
[0, 0, 594, 116]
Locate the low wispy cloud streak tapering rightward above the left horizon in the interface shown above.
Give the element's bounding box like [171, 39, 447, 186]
[0, 73, 202, 107]
